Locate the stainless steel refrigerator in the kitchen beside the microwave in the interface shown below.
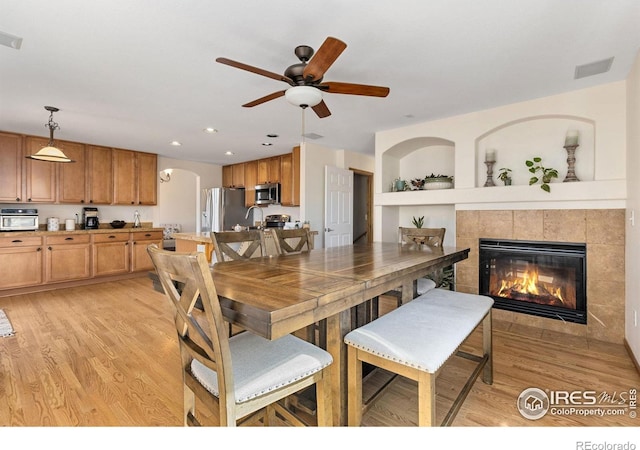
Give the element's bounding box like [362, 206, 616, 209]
[201, 188, 254, 231]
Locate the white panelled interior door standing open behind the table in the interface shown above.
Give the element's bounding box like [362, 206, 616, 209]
[324, 166, 353, 247]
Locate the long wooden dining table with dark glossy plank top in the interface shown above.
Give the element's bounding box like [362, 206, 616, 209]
[211, 242, 470, 425]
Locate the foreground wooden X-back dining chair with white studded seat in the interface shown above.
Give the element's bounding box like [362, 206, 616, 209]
[147, 244, 332, 426]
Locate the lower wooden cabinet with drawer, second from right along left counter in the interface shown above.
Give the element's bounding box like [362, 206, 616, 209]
[92, 232, 131, 277]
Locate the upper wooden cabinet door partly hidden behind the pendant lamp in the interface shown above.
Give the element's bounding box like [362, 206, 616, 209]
[24, 136, 56, 203]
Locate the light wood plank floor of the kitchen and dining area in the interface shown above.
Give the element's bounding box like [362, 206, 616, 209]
[0, 278, 640, 427]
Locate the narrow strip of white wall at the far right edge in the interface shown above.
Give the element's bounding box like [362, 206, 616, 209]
[625, 53, 640, 361]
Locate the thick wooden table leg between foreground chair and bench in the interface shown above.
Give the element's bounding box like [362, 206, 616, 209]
[327, 309, 351, 426]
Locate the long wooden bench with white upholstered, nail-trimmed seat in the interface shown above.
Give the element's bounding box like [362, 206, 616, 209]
[344, 289, 493, 426]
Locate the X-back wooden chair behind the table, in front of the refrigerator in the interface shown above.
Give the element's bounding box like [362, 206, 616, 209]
[211, 230, 266, 262]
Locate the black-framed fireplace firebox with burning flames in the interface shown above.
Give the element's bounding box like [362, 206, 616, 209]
[479, 239, 587, 324]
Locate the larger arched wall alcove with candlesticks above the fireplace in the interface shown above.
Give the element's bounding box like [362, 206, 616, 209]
[475, 115, 596, 187]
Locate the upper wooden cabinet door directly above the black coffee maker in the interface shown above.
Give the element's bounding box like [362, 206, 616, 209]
[86, 145, 113, 205]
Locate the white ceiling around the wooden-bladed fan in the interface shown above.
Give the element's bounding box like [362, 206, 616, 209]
[0, 0, 640, 164]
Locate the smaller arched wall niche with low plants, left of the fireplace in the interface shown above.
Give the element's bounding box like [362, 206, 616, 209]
[382, 136, 455, 192]
